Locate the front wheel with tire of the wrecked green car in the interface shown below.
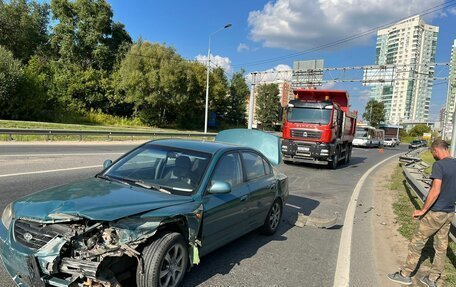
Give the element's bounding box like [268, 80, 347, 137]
[136, 232, 188, 287]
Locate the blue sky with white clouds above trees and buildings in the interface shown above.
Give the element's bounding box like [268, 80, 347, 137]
[79, 0, 456, 119]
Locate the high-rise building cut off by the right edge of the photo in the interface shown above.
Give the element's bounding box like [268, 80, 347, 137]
[443, 40, 456, 139]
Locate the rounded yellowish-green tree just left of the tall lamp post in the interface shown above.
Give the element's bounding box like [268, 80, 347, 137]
[115, 40, 191, 126]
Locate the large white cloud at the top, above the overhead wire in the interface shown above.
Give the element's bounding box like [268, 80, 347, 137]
[248, 0, 445, 50]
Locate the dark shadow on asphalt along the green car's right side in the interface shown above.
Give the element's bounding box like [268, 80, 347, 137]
[184, 195, 320, 286]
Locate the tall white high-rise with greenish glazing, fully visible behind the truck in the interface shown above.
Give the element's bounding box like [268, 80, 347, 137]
[371, 15, 439, 124]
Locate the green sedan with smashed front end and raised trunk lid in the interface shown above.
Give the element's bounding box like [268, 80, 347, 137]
[0, 129, 288, 287]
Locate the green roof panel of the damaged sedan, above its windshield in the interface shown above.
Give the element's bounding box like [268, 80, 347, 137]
[146, 139, 240, 154]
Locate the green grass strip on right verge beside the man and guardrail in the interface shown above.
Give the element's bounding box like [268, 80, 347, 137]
[389, 164, 456, 286]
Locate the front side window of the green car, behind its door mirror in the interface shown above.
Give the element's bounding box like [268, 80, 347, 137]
[211, 153, 242, 186]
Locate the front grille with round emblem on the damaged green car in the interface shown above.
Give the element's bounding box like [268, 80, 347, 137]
[14, 220, 59, 250]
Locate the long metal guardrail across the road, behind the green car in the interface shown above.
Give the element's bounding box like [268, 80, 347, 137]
[0, 128, 217, 141]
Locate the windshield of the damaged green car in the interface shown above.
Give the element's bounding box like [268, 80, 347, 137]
[98, 144, 210, 195]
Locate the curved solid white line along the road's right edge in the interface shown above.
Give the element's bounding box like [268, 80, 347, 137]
[333, 155, 398, 287]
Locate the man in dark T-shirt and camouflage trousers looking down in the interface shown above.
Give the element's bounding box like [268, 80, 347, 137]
[388, 139, 456, 287]
